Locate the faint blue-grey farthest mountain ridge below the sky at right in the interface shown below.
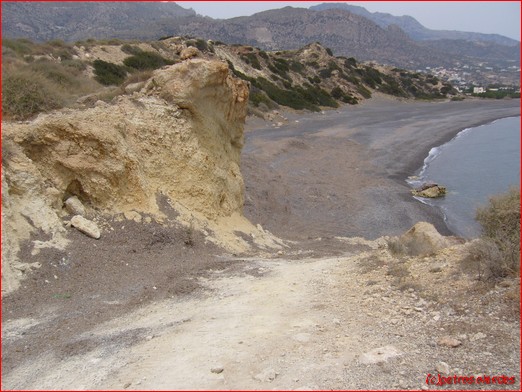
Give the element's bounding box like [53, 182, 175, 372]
[309, 3, 520, 46]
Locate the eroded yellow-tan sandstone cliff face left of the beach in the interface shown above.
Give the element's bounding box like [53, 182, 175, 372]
[2, 59, 278, 289]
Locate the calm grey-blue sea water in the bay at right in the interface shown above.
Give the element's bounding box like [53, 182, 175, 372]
[407, 117, 520, 239]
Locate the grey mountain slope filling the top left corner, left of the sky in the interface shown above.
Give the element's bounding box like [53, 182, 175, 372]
[2, 2, 196, 42]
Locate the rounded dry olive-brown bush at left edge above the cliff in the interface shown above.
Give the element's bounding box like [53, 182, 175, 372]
[2, 69, 64, 120]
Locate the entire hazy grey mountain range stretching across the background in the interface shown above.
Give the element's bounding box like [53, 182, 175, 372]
[2, 2, 520, 69]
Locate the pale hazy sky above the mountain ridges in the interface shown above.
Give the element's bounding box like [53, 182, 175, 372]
[176, 1, 520, 40]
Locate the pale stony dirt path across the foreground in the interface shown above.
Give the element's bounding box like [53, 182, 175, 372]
[3, 240, 520, 390]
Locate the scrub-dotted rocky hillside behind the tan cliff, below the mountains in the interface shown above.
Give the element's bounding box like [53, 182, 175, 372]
[2, 37, 456, 119]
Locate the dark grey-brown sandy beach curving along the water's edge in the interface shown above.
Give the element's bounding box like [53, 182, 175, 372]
[242, 96, 520, 240]
